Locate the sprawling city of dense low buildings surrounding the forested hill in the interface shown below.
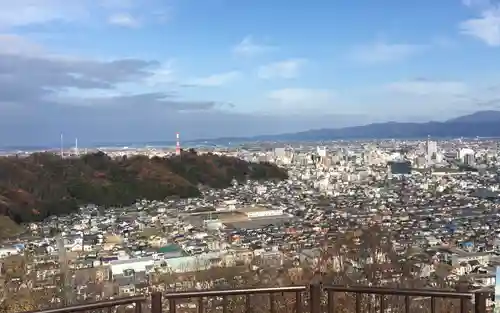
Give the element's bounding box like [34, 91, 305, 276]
[0, 135, 500, 310]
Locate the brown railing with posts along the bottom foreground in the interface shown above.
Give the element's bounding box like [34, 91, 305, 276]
[19, 284, 491, 313]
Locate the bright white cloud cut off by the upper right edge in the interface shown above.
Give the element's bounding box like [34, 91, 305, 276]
[459, 5, 500, 47]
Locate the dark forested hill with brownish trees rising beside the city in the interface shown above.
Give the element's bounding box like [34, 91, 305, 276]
[0, 150, 287, 223]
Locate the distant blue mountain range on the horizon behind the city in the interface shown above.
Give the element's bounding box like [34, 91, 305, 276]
[198, 111, 500, 143]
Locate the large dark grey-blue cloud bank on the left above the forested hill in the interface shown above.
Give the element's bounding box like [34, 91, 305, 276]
[0, 35, 223, 133]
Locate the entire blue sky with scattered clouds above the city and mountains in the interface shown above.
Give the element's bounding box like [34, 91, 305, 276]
[0, 0, 500, 146]
